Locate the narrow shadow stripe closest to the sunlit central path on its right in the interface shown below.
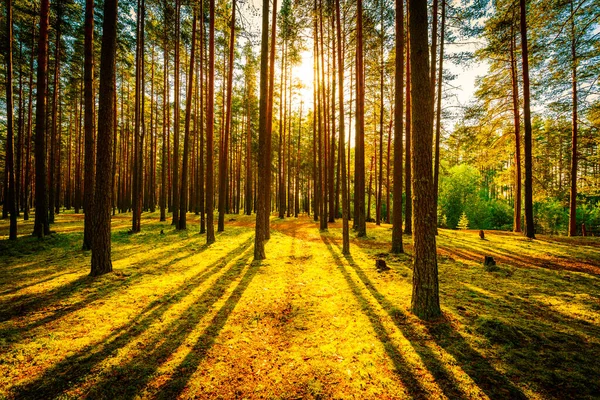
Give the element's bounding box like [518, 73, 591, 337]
[321, 235, 431, 399]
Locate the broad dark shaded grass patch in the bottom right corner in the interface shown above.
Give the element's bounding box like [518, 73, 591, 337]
[448, 282, 600, 398]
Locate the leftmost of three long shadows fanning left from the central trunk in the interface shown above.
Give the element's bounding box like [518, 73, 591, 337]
[11, 237, 254, 399]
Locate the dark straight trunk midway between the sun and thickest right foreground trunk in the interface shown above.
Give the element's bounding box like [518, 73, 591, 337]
[354, 0, 367, 237]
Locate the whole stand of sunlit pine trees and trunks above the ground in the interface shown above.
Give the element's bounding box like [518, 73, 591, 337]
[0, 0, 600, 310]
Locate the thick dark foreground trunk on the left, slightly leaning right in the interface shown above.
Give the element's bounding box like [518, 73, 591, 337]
[90, 0, 118, 276]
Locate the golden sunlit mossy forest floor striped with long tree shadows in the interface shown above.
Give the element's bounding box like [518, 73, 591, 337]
[0, 213, 600, 399]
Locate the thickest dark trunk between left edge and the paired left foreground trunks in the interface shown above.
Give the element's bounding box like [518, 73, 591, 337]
[33, 0, 50, 239]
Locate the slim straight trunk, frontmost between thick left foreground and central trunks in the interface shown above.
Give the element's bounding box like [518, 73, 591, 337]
[206, 0, 215, 244]
